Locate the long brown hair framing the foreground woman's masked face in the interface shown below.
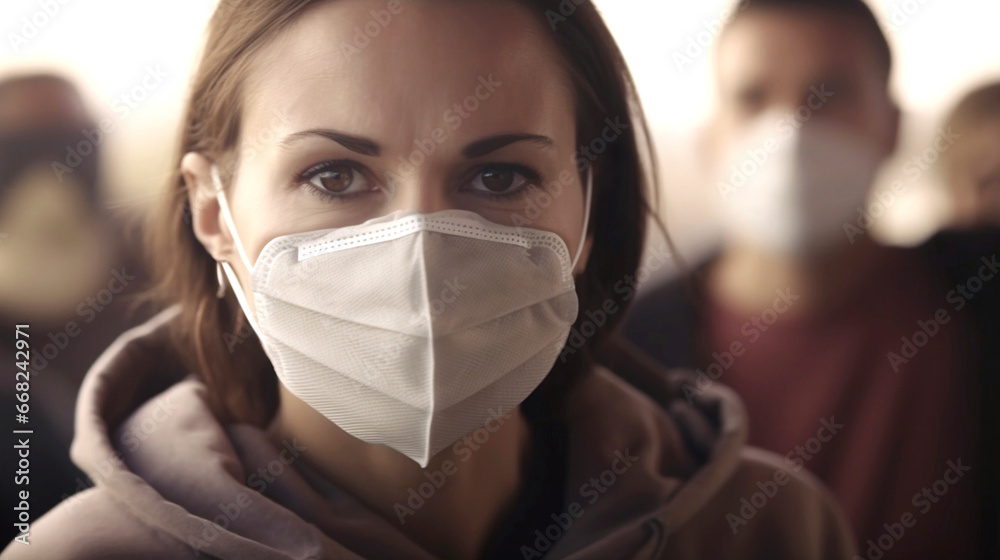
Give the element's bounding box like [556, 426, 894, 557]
[148, 0, 662, 424]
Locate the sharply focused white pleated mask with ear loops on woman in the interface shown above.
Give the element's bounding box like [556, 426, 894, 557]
[212, 168, 591, 467]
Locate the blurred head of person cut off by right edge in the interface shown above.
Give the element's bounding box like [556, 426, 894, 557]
[941, 82, 1000, 228]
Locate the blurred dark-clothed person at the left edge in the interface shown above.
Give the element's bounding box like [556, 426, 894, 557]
[0, 73, 152, 540]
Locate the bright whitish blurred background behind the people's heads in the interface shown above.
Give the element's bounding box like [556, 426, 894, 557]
[0, 0, 1000, 270]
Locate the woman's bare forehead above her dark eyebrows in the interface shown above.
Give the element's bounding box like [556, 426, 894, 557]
[237, 0, 575, 151]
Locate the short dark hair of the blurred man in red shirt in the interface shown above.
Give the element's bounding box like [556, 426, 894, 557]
[729, 0, 892, 83]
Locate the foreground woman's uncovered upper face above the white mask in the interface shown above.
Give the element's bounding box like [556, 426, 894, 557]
[189, 0, 585, 302]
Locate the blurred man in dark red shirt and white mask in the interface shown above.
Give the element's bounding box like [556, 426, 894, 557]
[625, 0, 1000, 560]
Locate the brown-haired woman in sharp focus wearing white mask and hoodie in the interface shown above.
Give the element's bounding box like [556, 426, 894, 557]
[5, 0, 851, 559]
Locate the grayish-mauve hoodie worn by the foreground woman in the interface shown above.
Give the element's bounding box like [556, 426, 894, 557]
[0, 308, 854, 560]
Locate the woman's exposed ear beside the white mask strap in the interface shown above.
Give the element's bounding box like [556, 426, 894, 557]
[181, 152, 233, 260]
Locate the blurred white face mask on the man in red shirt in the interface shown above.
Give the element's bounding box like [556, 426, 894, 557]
[716, 112, 880, 256]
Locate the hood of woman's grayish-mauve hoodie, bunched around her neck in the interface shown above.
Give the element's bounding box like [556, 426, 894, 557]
[62, 307, 746, 560]
